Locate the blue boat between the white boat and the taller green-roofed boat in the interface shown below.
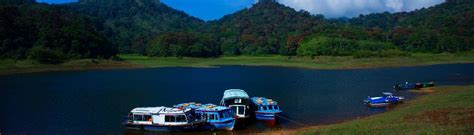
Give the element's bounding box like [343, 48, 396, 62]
[174, 102, 235, 130]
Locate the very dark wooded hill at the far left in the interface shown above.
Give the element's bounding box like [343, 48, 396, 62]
[0, 2, 117, 63]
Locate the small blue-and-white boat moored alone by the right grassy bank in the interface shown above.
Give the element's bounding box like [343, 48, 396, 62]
[364, 92, 405, 107]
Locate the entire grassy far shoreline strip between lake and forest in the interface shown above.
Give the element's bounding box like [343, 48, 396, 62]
[0, 54, 474, 75]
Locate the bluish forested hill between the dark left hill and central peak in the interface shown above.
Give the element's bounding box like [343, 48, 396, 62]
[65, 0, 204, 53]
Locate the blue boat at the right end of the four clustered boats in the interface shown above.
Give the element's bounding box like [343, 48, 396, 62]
[250, 97, 282, 126]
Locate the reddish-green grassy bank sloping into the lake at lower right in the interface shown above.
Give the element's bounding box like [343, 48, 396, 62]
[275, 86, 474, 135]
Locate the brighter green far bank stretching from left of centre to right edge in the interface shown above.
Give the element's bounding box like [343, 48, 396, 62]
[120, 54, 474, 69]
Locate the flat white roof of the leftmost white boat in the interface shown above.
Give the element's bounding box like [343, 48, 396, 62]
[130, 106, 191, 114]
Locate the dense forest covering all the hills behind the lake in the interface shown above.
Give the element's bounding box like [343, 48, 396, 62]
[0, 0, 474, 63]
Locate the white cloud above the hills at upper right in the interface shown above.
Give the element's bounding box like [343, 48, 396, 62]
[278, 0, 445, 18]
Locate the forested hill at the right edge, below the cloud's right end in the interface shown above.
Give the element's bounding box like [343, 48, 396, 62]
[349, 0, 474, 52]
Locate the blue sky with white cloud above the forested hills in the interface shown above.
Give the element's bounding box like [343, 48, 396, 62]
[37, 0, 445, 21]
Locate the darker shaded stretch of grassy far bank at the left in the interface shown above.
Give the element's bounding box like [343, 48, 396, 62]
[0, 59, 141, 75]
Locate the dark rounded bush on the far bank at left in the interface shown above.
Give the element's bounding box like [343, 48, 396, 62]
[28, 47, 67, 64]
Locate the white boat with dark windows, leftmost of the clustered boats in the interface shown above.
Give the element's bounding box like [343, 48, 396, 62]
[125, 106, 204, 131]
